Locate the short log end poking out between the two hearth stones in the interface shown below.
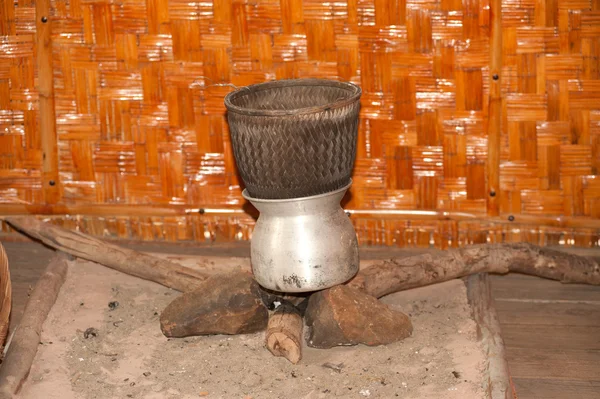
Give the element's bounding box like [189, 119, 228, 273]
[265, 303, 304, 364]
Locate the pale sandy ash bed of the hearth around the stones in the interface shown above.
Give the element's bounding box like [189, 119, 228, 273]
[20, 260, 485, 399]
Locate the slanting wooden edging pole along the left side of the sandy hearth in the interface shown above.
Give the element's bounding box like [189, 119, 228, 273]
[0, 254, 67, 399]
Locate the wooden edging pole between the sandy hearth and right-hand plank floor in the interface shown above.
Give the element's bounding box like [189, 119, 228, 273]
[466, 273, 512, 399]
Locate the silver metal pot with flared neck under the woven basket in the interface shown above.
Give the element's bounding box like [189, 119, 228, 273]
[243, 183, 359, 292]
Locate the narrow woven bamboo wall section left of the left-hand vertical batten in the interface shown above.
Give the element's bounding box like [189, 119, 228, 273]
[0, 1, 43, 203]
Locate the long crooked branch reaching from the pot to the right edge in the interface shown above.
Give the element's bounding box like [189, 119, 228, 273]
[348, 243, 600, 298]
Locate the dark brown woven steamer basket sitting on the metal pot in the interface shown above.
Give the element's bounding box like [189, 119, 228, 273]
[225, 79, 361, 199]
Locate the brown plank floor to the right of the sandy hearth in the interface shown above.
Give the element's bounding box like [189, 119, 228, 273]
[491, 274, 600, 399]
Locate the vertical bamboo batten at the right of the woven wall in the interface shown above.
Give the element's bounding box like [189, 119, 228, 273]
[487, 0, 502, 216]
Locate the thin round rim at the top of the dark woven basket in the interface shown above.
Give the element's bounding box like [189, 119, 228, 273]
[225, 78, 362, 116]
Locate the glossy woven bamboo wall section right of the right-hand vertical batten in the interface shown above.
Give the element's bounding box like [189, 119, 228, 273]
[501, 0, 600, 222]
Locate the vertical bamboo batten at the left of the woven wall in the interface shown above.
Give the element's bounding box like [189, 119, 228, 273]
[35, 0, 60, 204]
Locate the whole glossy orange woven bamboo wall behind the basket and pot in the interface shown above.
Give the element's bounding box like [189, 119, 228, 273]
[0, 0, 600, 247]
